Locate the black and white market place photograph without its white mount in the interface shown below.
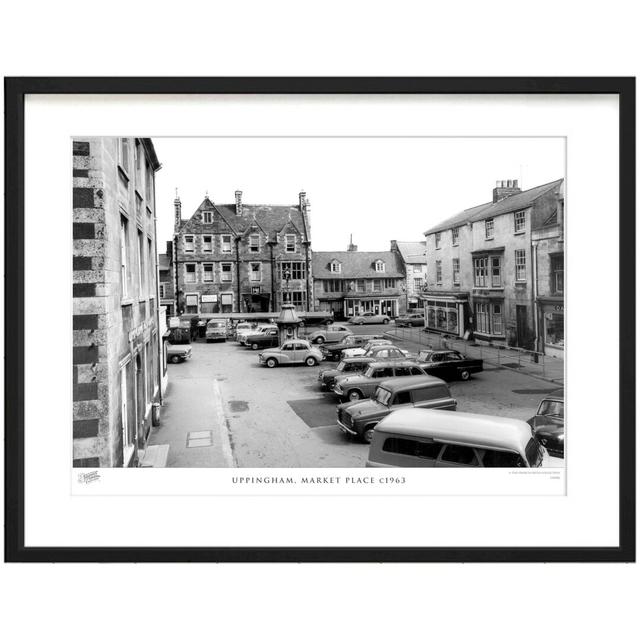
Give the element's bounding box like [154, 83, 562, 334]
[69, 135, 572, 470]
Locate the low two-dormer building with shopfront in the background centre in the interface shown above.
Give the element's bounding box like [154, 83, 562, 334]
[313, 238, 406, 319]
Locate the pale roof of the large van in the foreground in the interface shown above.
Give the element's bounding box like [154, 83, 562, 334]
[376, 408, 531, 451]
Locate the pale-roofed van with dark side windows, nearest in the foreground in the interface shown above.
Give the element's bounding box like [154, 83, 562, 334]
[366, 409, 548, 468]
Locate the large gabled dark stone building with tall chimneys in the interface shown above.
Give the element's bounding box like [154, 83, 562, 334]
[173, 191, 313, 314]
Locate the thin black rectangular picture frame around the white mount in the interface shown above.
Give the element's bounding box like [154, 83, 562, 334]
[4, 77, 636, 562]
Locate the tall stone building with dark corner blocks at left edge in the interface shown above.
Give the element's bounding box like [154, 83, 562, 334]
[73, 137, 162, 467]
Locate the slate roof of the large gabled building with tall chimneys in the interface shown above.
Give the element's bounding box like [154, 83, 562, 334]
[180, 198, 309, 240]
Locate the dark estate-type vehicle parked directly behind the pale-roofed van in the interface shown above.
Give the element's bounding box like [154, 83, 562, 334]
[337, 376, 458, 443]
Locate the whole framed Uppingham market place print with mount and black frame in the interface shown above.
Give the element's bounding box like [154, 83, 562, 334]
[5, 78, 635, 562]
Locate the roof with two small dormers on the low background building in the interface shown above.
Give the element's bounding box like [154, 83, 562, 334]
[312, 251, 404, 279]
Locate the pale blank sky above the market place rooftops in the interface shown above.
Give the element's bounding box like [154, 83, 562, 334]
[153, 137, 565, 252]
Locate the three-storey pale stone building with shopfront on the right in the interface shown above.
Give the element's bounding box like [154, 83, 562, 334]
[425, 180, 564, 355]
